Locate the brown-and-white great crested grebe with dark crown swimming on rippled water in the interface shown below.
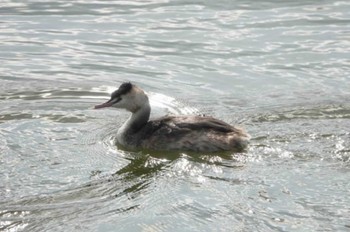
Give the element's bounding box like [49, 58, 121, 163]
[95, 83, 250, 152]
